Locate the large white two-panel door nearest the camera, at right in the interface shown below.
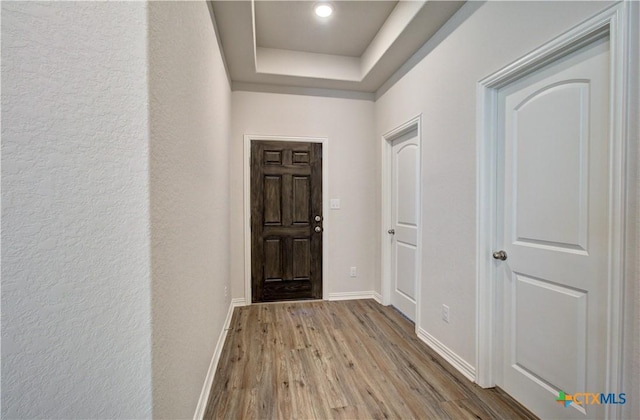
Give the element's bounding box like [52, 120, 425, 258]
[494, 38, 610, 419]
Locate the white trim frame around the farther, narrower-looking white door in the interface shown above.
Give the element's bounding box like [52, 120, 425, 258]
[380, 113, 423, 328]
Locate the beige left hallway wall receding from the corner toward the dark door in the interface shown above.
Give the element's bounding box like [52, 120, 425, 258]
[149, 2, 231, 418]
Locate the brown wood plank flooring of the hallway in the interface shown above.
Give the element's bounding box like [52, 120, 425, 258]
[205, 300, 536, 419]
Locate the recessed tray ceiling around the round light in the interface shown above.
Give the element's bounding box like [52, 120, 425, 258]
[211, 0, 464, 94]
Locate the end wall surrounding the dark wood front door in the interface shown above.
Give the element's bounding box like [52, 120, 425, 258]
[230, 92, 379, 297]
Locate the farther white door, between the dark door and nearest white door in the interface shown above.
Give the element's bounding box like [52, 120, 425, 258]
[390, 129, 420, 321]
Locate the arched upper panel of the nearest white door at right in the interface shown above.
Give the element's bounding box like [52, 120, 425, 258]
[512, 81, 589, 250]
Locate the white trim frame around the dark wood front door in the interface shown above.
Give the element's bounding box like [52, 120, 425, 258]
[243, 134, 331, 305]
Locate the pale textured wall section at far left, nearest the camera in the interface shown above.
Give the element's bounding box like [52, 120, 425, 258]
[2, 2, 152, 418]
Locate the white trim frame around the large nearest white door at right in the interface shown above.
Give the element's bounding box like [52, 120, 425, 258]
[476, 2, 633, 418]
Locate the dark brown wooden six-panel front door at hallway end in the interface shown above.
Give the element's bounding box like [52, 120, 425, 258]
[251, 140, 323, 302]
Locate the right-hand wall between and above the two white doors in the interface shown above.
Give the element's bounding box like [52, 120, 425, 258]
[376, 2, 620, 366]
